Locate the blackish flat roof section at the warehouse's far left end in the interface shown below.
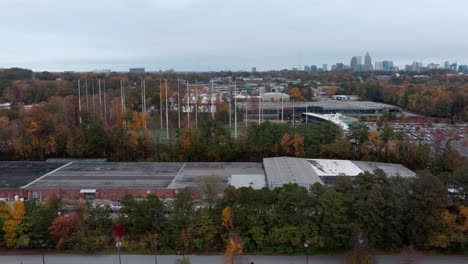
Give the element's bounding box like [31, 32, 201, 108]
[0, 161, 64, 189]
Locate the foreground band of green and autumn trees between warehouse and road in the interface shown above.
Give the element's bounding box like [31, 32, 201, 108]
[0, 170, 468, 257]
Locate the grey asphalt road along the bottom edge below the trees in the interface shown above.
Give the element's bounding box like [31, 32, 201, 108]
[0, 255, 468, 264]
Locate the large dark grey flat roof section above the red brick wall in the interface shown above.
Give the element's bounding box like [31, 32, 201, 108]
[26, 162, 184, 189]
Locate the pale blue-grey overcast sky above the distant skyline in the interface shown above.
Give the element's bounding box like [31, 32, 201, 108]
[0, 0, 468, 71]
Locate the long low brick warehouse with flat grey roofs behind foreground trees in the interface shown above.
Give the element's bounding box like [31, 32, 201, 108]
[0, 157, 415, 200]
